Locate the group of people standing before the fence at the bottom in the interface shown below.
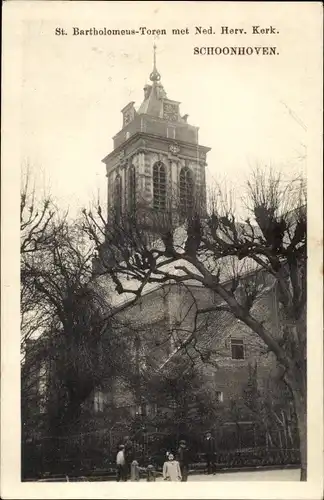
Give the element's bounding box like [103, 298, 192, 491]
[116, 431, 216, 482]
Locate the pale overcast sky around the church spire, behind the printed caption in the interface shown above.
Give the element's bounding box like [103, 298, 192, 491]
[19, 2, 318, 217]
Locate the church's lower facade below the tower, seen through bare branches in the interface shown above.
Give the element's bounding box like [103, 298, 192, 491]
[92, 274, 278, 426]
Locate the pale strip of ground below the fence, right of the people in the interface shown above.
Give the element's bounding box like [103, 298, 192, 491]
[153, 469, 300, 481]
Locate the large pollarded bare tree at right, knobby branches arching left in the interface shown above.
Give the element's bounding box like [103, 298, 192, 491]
[84, 170, 307, 480]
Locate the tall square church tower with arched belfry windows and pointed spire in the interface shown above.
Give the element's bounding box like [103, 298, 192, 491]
[102, 45, 210, 226]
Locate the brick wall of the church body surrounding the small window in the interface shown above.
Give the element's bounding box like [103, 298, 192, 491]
[98, 285, 277, 420]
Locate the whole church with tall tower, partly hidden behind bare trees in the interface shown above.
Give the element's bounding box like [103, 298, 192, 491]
[24, 46, 302, 476]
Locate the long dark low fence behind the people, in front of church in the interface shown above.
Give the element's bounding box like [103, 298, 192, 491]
[22, 425, 299, 477]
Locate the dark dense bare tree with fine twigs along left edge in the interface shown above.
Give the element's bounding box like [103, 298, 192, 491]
[21, 183, 134, 472]
